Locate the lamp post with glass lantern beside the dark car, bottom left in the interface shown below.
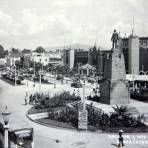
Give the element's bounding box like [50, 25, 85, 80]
[2, 106, 11, 148]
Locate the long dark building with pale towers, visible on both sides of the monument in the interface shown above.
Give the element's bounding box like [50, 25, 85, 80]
[63, 34, 148, 76]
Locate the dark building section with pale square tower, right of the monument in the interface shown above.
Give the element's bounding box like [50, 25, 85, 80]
[122, 35, 148, 74]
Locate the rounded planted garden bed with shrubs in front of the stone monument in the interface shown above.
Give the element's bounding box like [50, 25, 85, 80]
[28, 92, 148, 133]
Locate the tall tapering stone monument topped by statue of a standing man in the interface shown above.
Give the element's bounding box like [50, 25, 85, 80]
[100, 29, 129, 104]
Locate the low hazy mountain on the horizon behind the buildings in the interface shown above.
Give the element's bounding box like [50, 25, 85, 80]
[45, 43, 91, 51]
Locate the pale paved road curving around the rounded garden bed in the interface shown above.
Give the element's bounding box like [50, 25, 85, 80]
[0, 80, 148, 148]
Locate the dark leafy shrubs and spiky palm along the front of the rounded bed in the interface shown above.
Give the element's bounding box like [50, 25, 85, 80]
[46, 103, 146, 131]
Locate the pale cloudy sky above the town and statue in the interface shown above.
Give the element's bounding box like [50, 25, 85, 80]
[0, 0, 148, 49]
